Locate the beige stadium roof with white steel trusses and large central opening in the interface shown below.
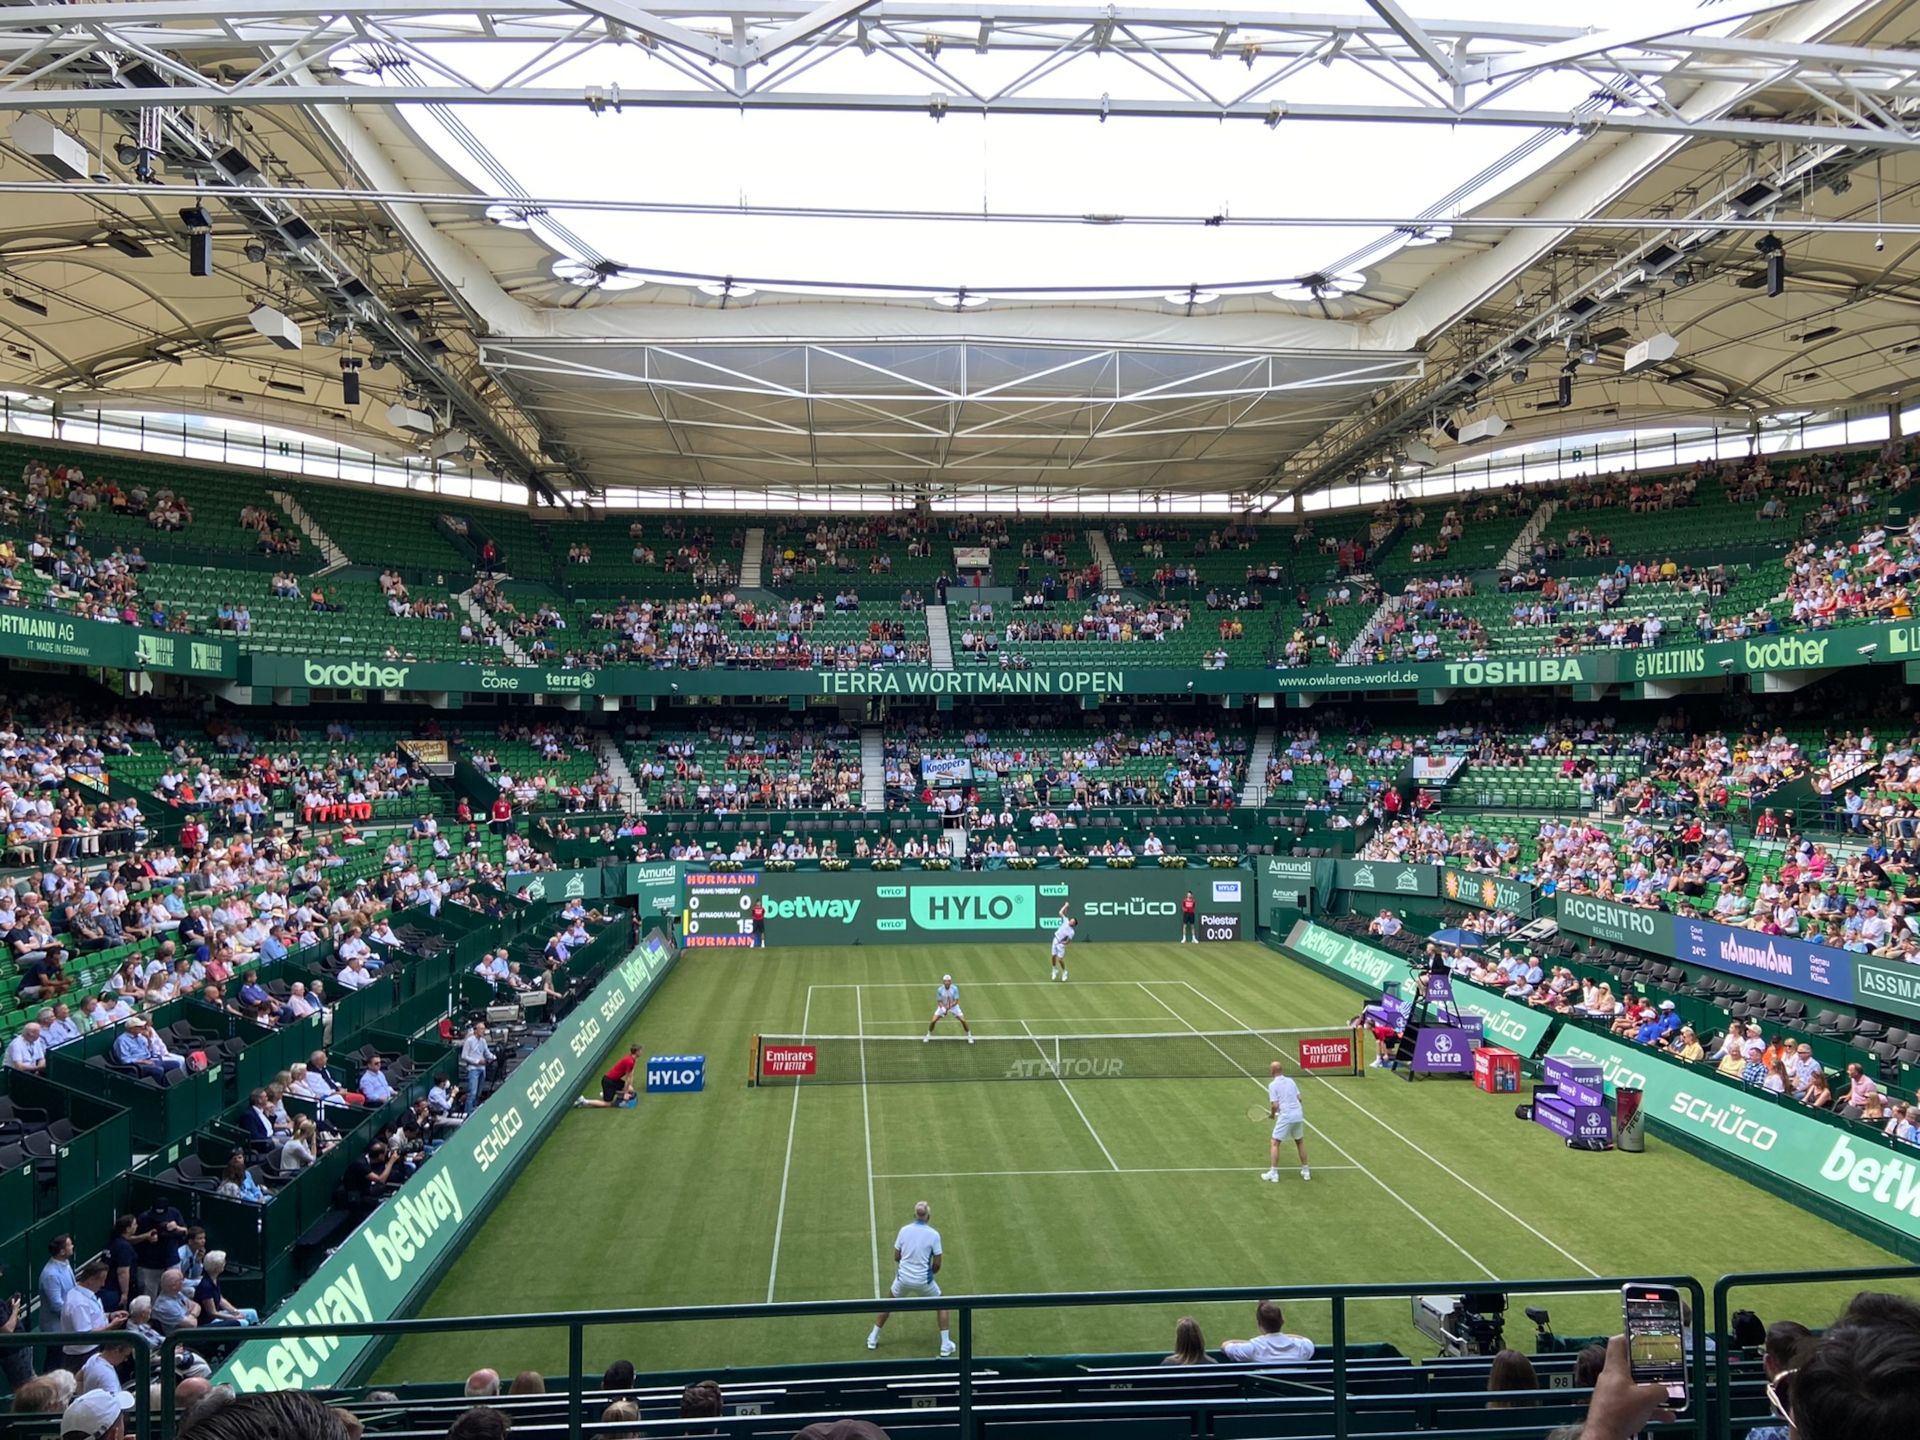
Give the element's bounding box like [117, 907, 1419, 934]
[0, 0, 1920, 509]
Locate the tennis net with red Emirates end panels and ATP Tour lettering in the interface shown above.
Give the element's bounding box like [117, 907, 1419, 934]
[749, 1029, 1363, 1085]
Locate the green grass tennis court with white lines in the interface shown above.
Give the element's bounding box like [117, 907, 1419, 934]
[384, 941, 1893, 1379]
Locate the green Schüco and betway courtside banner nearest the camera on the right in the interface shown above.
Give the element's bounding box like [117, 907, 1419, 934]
[1549, 1025, 1920, 1252]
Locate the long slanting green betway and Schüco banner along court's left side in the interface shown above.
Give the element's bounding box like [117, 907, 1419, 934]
[213, 931, 676, 1390]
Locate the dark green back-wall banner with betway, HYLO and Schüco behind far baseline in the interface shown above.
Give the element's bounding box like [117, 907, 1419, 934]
[684, 864, 1254, 948]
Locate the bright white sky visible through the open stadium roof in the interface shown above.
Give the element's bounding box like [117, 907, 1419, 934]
[385, 0, 1695, 298]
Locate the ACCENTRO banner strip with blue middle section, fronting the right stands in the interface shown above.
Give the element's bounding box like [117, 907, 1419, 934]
[1557, 895, 1920, 1020]
